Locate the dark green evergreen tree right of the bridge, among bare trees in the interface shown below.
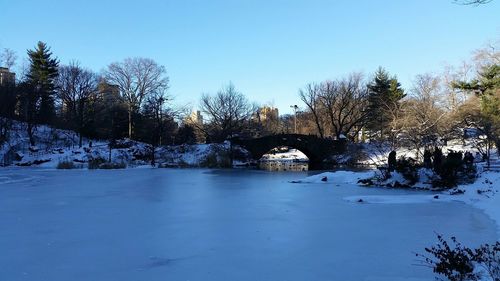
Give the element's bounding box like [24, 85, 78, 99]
[367, 67, 405, 138]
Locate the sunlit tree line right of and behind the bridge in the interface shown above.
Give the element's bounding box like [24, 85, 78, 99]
[299, 44, 500, 161]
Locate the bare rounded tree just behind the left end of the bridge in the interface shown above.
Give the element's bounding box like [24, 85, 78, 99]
[201, 83, 256, 141]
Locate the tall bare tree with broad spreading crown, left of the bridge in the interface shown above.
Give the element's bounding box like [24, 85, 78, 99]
[104, 58, 169, 138]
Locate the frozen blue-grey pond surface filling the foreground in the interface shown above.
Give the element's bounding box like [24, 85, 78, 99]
[0, 169, 497, 281]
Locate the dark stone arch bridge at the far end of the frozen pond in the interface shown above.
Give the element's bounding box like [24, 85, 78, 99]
[232, 134, 346, 170]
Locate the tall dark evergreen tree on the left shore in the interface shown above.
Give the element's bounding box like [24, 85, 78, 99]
[27, 42, 59, 123]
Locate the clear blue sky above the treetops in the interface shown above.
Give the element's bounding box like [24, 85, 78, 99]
[0, 0, 500, 113]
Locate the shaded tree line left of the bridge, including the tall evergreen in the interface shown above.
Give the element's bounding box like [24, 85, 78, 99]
[0, 42, 177, 146]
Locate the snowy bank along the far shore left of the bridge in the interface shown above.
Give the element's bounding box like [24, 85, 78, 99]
[0, 122, 249, 168]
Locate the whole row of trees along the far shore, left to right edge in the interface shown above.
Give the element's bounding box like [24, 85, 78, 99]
[0, 42, 500, 162]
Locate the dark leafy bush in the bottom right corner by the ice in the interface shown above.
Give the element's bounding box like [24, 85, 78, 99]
[416, 235, 500, 281]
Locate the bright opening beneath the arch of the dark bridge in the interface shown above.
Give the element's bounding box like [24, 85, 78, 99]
[258, 146, 309, 171]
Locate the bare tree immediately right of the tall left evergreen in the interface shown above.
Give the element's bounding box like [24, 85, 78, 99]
[56, 62, 98, 147]
